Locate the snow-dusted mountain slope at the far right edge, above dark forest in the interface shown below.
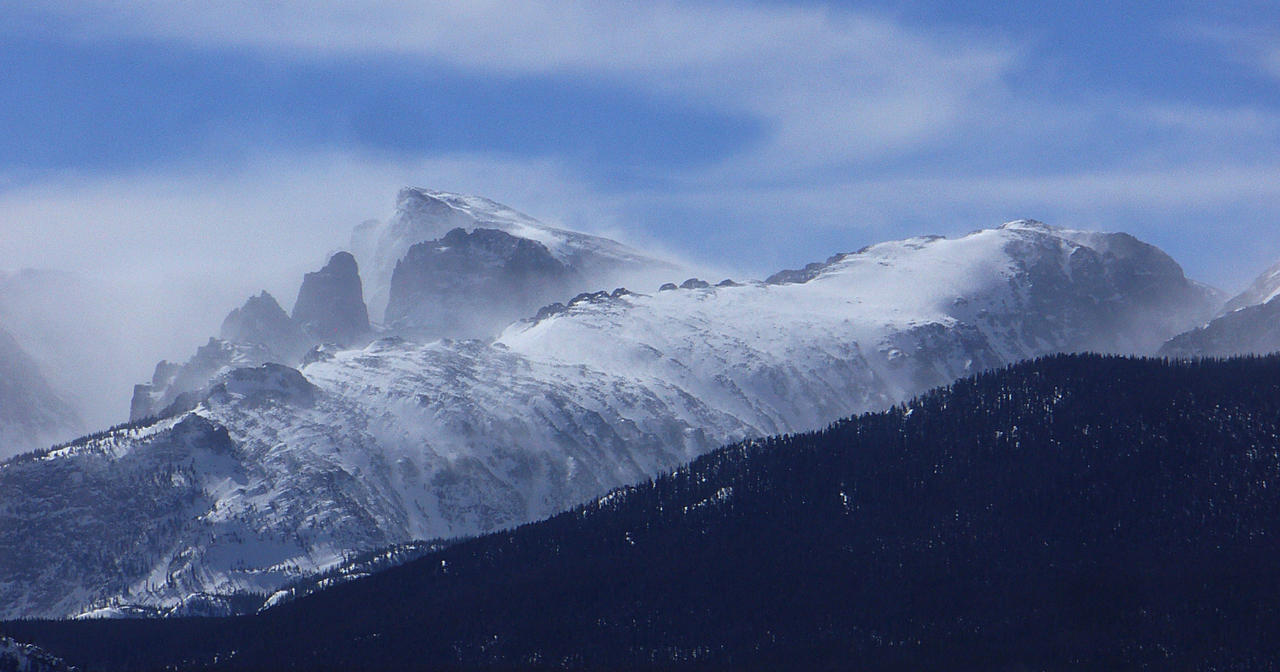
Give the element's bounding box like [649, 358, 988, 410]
[1160, 257, 1280, 357]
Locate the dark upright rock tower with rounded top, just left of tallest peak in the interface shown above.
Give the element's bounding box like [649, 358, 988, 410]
[293, 252, 369, 346]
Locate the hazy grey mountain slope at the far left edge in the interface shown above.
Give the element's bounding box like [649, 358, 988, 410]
[0, 329, 83, 458]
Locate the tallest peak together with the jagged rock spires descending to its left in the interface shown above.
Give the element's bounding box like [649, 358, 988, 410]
[129, 188, 678, 421]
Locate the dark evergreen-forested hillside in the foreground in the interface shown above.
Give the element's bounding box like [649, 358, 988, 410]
[0, 356, 1280, 672]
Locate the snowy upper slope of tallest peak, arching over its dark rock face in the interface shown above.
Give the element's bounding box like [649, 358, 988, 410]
[351, 188, 677, 326]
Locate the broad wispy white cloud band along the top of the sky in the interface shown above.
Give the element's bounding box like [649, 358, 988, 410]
[17, 0, 1016, 173]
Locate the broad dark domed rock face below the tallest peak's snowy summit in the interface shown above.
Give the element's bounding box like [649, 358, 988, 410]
[387, 228, 582, 339]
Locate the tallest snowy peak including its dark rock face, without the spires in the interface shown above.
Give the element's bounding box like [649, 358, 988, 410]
[351, 188, 678, 330]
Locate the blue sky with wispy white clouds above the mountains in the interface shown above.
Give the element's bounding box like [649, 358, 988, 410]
[0, 0, 1280, 296]
